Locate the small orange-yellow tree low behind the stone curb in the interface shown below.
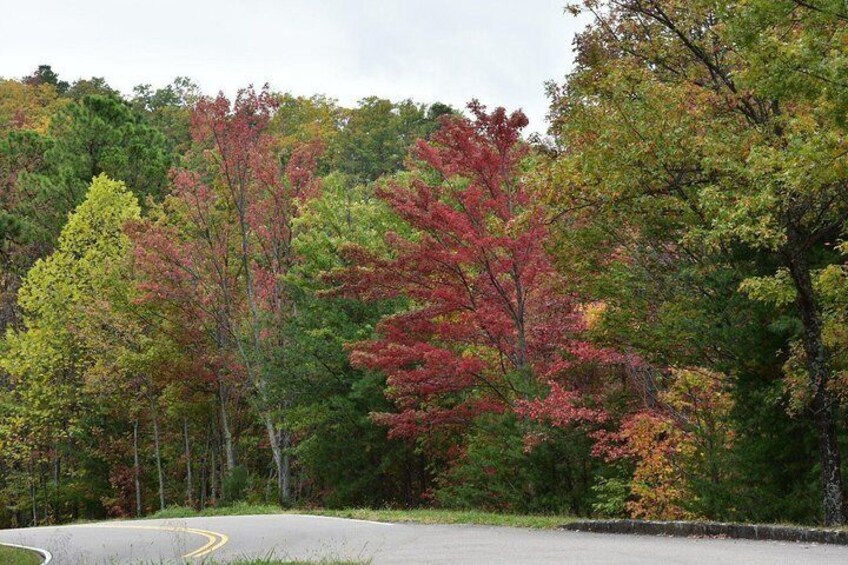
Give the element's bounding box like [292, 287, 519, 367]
[595, 368, 736, 520]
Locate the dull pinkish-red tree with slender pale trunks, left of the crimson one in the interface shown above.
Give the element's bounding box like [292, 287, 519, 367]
[135, 89, 321, 499]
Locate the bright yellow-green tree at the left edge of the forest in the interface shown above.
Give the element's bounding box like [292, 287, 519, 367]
[0, 176, 140, 523]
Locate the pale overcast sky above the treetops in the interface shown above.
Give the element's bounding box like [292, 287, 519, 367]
[0, 0, 582, 131]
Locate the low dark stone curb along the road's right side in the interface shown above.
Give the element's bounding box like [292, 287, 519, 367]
[560, 520, 848, 545]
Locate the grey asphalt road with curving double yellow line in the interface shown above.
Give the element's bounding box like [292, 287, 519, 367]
[0, 514, 848, 565]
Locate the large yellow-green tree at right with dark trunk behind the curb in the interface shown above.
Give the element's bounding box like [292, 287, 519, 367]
[551, 0, 848, 524]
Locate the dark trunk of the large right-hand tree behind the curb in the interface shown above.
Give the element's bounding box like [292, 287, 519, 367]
[789, 238, 845, 526]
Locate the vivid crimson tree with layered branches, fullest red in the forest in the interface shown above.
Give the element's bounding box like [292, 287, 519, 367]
[339, 102, 616, 437]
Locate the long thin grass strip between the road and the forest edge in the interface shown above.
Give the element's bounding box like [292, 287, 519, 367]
[150, 503, 574, 529]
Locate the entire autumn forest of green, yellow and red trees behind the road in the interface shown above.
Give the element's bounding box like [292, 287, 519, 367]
[0, 0, 848, 527]
